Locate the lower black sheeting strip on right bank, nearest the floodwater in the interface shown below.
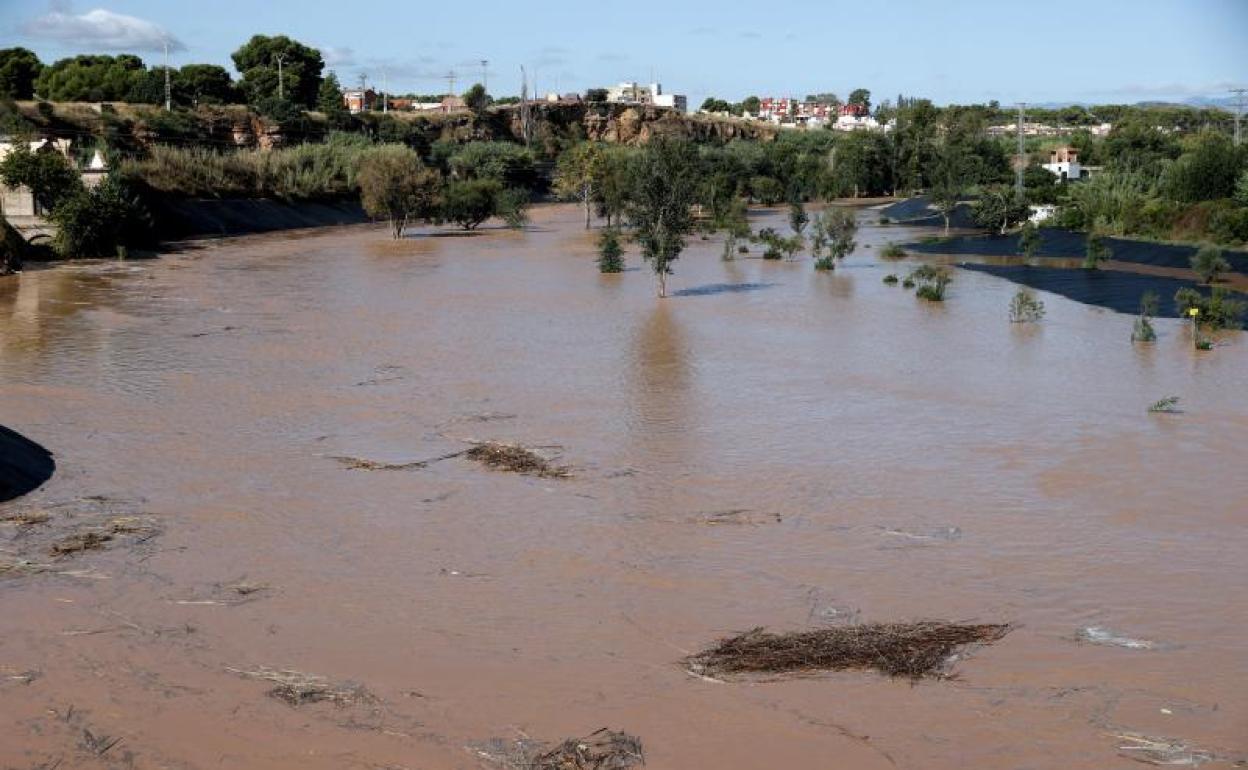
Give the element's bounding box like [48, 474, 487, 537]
[958, 262, 1209, 318]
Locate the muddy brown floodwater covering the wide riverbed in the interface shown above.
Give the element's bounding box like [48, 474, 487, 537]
[0, 200, 1248, 770]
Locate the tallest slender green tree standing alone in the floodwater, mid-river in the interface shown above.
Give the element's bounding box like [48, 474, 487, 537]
[628, 137, 698, 297]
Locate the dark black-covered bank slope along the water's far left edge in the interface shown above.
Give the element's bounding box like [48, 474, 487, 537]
[152, 198, 369, 240]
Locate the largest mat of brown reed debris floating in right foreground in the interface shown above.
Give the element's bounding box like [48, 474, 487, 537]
[685, 620, 1010, 680]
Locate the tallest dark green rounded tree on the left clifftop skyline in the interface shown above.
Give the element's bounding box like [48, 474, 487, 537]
[231, 35, 324, 110]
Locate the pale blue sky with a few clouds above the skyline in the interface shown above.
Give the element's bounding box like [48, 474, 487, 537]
[0, 0, 1248, 105]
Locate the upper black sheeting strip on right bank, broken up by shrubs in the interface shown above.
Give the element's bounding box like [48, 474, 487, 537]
[906, 227, 1248, 273]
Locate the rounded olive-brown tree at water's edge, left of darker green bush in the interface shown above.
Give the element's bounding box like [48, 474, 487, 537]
[356, 145, 442, 238]
